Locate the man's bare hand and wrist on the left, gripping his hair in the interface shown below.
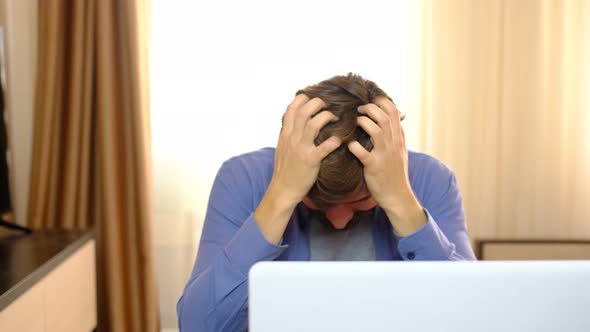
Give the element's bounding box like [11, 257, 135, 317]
[254, 94, 342, 243]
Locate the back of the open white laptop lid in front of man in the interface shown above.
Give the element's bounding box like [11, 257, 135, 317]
[248, 261, 590, 332]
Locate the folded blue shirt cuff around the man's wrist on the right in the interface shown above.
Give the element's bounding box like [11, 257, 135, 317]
[394, 209, 455, 260]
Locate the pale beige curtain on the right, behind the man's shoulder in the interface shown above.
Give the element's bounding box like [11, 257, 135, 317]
[419, 0, 590, 243]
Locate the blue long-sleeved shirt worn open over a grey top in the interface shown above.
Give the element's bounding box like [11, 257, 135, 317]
[177, 148, 475, 332]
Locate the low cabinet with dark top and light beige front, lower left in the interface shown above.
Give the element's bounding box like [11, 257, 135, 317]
[0, 229, 96, 332]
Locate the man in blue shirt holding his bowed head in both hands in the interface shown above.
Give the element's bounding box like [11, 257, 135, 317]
[177, 74, 474, 331]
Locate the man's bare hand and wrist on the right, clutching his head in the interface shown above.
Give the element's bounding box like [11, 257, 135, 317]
[348, 97, 426, 236]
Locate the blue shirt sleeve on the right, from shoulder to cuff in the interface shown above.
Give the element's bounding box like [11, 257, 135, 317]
[394, 164, 475, 260]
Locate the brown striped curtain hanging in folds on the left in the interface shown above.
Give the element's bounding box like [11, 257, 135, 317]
[28, 0, 158, 331]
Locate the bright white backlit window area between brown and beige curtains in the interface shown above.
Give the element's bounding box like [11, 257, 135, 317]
[151, 0, 421, 328]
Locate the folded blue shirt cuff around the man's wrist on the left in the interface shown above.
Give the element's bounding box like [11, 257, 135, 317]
[225, 214, 289, 275]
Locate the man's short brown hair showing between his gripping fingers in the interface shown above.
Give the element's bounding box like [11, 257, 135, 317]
[296, 73, 400, 207]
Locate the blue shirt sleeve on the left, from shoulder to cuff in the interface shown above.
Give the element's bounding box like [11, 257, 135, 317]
[177, 159, 287, 332]
